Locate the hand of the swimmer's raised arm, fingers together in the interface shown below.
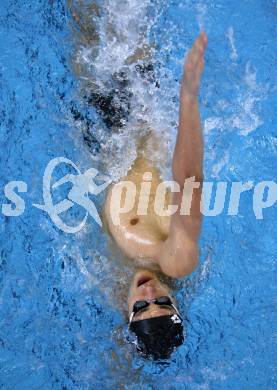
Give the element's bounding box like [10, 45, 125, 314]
[182, 32, 208, 98]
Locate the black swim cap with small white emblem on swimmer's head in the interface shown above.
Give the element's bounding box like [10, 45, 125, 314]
[130, 314, 184, 360]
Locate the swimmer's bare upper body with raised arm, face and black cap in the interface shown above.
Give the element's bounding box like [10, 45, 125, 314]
[105, 32, 208, 358]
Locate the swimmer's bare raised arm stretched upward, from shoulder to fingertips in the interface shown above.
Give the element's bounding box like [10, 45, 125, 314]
[159, 33, 208, 277]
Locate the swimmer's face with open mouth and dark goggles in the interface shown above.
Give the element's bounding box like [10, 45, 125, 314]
[128, 271, 175, 321]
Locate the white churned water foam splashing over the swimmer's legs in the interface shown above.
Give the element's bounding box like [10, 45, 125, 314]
[71, 0, 177, 181]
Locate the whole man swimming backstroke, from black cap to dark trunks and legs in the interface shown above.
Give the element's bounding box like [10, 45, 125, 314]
[68, 0, 208, 359]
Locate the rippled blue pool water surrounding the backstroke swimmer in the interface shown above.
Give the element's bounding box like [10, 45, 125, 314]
[0, 0, 277, 390]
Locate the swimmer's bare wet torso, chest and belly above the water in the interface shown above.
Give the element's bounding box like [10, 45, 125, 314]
[105, 157, 170, 262]
